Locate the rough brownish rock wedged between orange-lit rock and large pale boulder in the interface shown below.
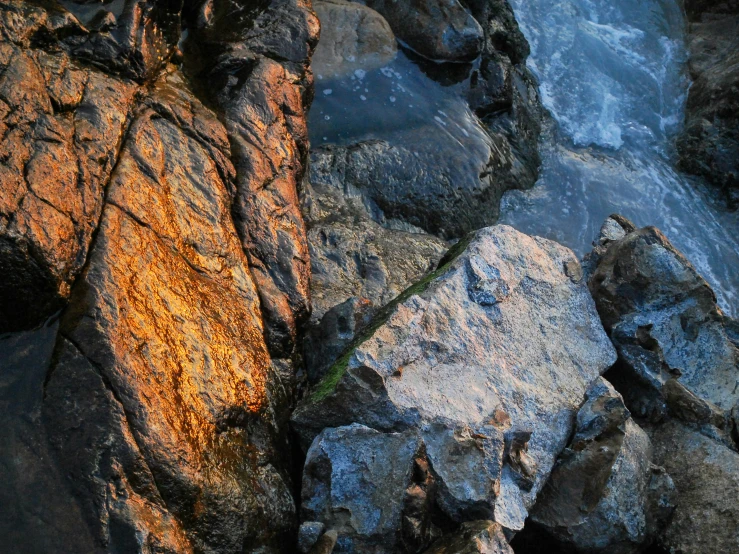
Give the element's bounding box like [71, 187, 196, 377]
[302, 144, 448, 381]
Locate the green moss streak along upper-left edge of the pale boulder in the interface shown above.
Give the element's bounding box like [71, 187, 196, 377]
[307, 233, 475, 404]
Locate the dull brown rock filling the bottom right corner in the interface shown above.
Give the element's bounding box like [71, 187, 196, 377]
[652, 421, 739, 554]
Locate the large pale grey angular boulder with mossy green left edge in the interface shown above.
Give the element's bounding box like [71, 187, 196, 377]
[293, 226, 615, 530]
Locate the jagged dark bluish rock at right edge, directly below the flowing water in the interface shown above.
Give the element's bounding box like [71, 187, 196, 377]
[589, 215, 739, 427]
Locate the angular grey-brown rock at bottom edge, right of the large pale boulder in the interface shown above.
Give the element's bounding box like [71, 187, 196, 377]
[524, 378, 676, 554]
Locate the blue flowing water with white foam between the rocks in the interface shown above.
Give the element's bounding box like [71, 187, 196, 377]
[501, 0, 739, 316]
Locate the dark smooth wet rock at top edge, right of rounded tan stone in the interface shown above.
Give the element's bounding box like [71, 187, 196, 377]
[366, 0, 483, 62]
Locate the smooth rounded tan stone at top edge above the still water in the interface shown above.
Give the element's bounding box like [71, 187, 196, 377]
[311, 0, 398, 78]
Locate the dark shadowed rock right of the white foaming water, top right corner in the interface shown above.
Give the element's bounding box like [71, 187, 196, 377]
[677, 0, 739, 207]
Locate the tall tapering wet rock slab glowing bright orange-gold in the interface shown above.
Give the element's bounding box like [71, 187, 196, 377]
[48, 75, 294, 552]
